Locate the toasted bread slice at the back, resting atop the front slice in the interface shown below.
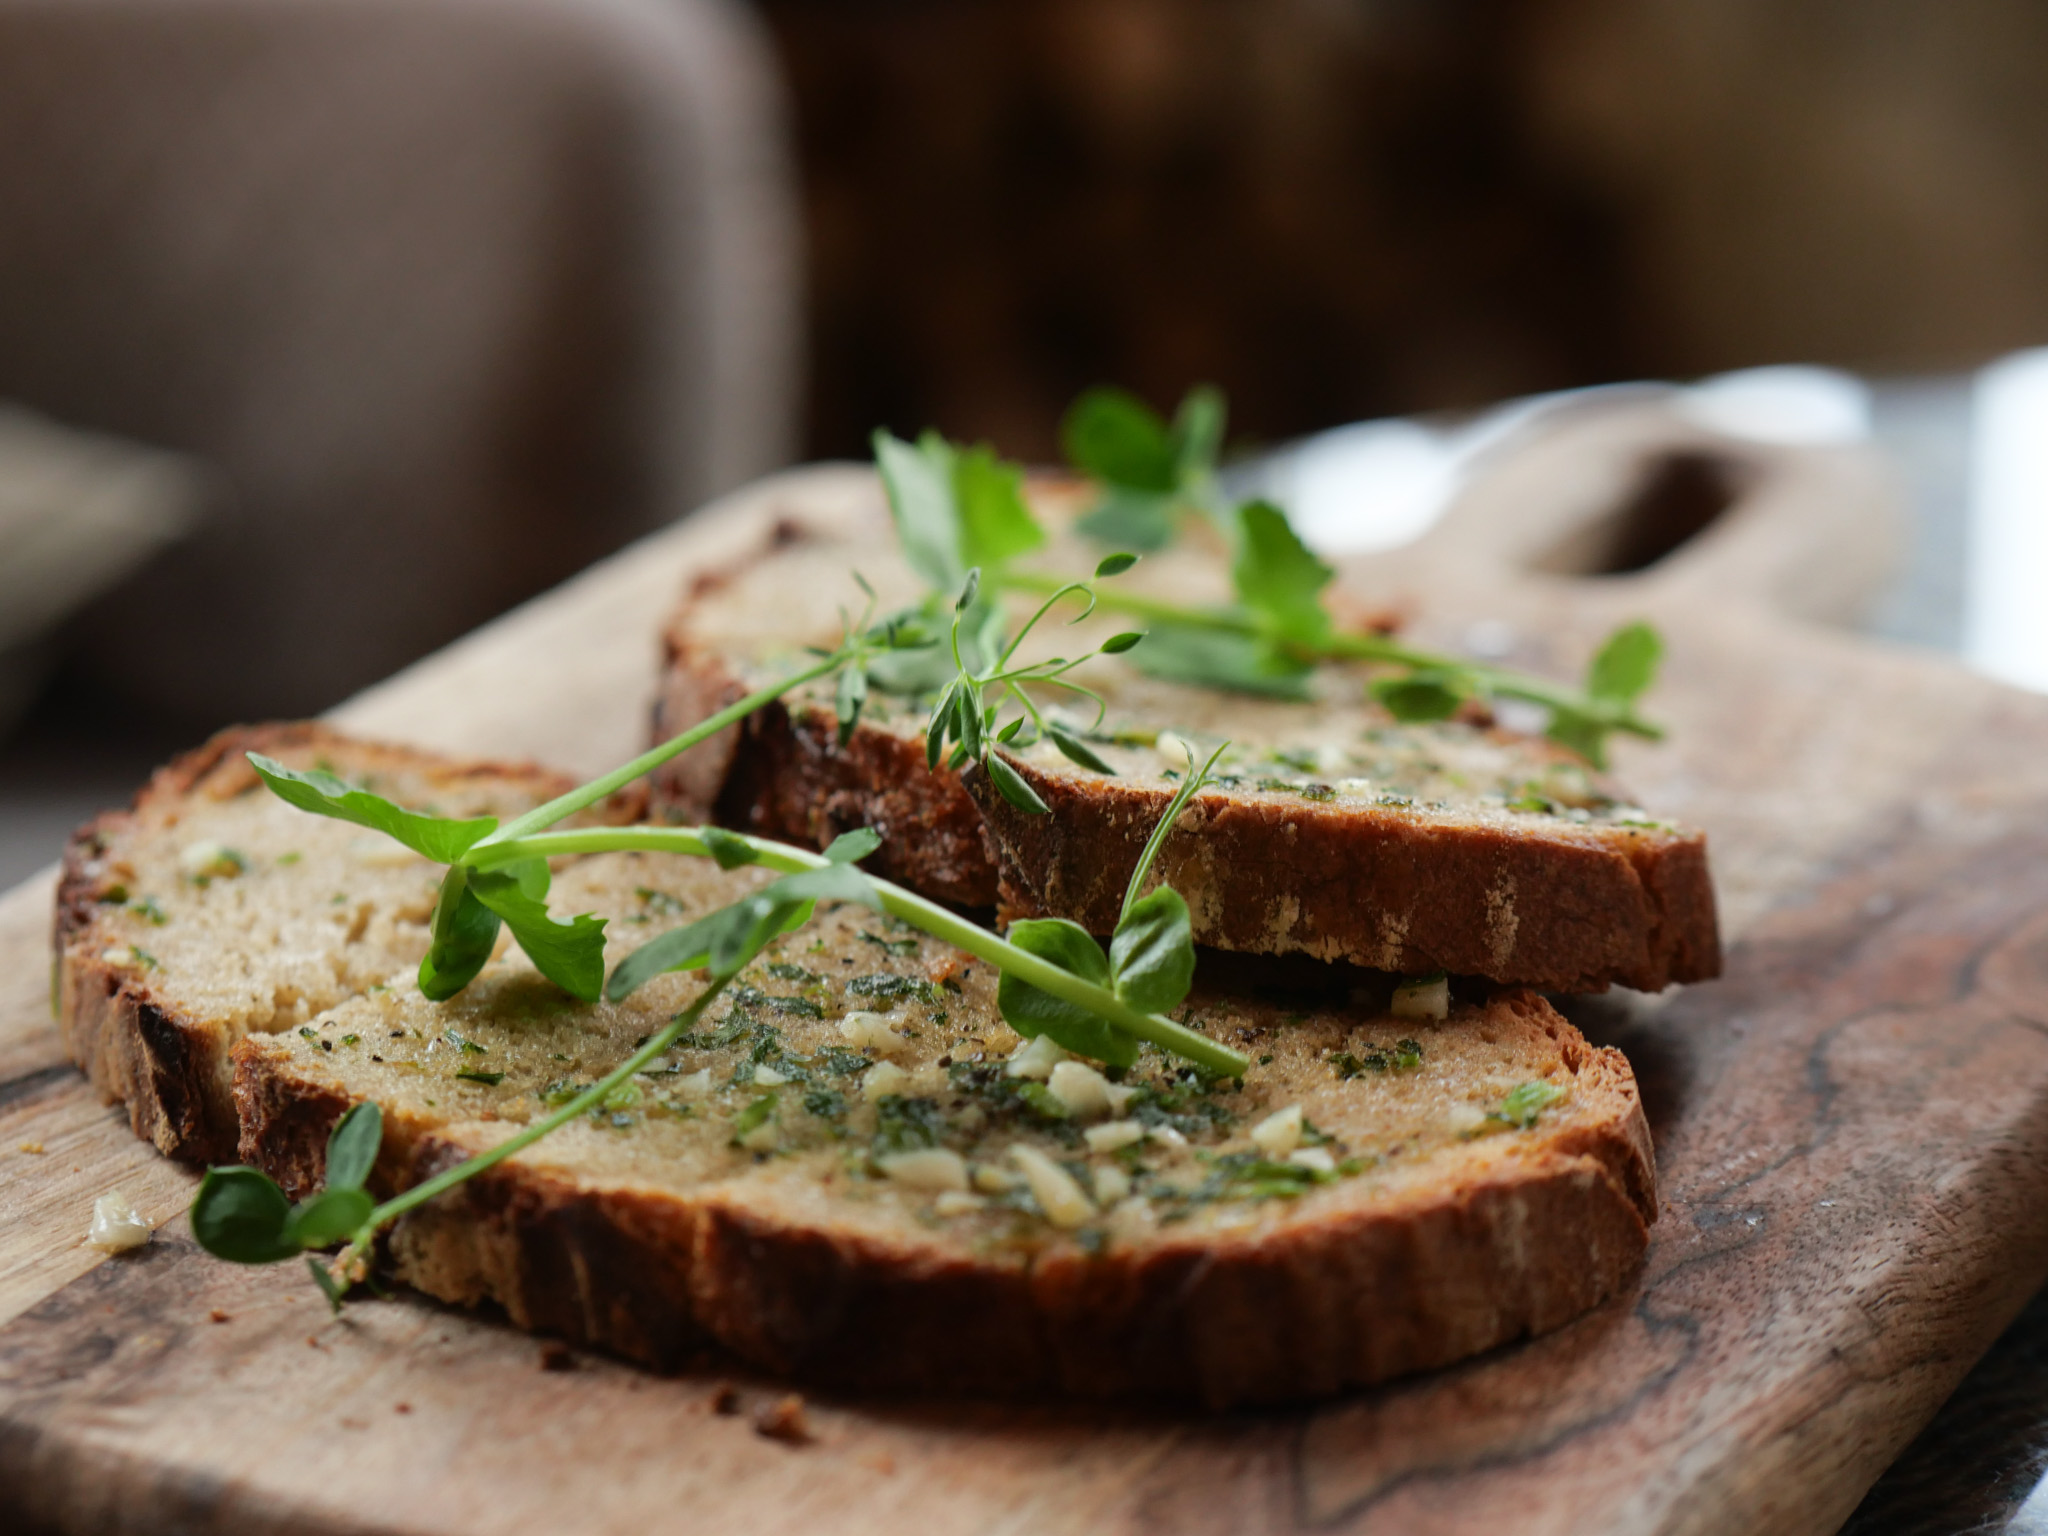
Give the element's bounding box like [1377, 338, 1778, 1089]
[653, 506, 1720, 991]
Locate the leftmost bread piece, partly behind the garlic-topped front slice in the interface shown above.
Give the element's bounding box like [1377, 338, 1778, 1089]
[55, 725, 571, 1161]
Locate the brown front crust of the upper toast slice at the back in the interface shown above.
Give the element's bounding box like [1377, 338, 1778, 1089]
[965, 762, 1720, 991]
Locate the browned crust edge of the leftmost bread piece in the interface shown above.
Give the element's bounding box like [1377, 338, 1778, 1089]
[51, 721, 571, 1163]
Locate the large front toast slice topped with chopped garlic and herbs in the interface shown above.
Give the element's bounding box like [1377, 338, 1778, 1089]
[236, 854, 1655, 1405]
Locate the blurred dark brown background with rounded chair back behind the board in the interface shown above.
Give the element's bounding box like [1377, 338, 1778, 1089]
[0, 0, 2048, 885]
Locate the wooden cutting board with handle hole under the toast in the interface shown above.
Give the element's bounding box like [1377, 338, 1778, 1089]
[0, 403, 2048, 1536]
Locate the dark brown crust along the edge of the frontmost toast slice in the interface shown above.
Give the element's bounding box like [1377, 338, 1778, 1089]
[236, 993, 1657, 1407]
